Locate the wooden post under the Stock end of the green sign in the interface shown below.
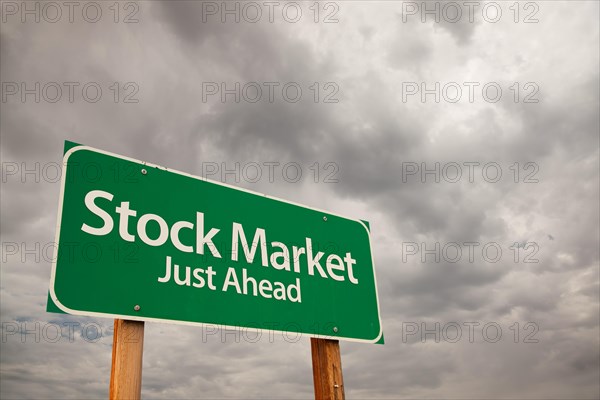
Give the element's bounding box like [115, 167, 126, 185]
[109, 319, 144, 400]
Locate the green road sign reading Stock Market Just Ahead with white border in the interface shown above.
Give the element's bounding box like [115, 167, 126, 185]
[48, 142, 382, 343]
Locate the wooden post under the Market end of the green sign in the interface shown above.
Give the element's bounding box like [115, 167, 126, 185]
[310, 338, 345, 400]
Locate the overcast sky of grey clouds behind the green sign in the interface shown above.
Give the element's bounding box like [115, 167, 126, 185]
[0, 1, 600, 399]
